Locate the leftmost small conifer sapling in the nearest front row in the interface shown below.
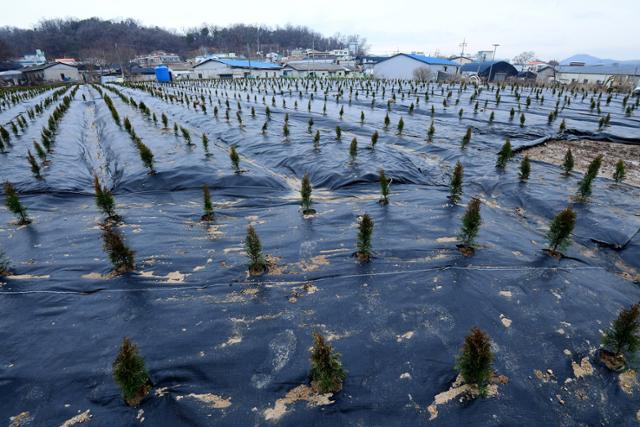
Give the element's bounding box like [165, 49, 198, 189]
[113, 337, 151, 406]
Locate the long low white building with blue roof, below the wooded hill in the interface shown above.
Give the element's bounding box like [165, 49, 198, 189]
[193, 58, 282, 79]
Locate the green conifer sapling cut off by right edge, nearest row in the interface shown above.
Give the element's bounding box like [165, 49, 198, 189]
[602, 304, 640, 360]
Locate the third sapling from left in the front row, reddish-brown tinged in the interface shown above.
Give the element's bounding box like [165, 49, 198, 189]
[456, 327, 493, 395]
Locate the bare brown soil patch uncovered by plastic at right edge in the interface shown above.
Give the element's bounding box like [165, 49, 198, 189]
[525, 139, 640, 187]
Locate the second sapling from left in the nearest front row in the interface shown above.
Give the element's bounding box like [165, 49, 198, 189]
[311, 332, 347, 394]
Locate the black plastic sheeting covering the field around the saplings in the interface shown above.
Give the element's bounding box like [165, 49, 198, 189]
[0, 79, 640, 426]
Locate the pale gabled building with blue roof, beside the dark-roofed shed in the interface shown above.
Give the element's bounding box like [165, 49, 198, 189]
[373, 53, 460, 81]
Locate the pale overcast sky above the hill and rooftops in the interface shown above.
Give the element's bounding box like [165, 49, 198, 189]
[0, 0, 640, 59]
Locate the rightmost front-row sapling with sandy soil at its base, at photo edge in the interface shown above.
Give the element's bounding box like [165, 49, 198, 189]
[600, 304, 640, 371]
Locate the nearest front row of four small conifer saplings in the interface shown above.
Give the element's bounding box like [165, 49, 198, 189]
[113, 304, 640, 406]
